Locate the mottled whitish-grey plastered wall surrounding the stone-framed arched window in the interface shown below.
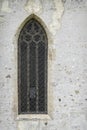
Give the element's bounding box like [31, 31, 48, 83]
[0, 0, 87, 130]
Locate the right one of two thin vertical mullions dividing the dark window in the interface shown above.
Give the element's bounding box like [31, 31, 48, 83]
[36, 43, 38, 113]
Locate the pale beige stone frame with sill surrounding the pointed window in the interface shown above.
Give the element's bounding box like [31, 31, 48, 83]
[14, 14, 53, 120]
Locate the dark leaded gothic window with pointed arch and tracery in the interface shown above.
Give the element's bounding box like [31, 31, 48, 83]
[18, 18, 48, 114]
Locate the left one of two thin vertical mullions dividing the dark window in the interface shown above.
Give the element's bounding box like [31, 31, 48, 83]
[27, 44, 30, 112]
